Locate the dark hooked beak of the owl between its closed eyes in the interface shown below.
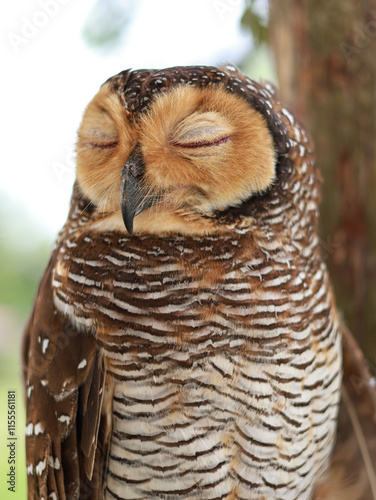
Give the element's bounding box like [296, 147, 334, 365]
[120, 146, 156, 234]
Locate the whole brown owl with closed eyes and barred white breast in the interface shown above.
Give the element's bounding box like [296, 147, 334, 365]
[23, 66, 376, 500]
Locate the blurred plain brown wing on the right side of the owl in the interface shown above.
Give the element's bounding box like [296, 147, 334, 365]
[315, 325, 376, 500]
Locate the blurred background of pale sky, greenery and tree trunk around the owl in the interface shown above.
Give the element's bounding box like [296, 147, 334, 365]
[0, 0, 376, 499]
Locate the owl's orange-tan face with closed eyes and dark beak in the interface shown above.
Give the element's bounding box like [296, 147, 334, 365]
[77, 66, 276, 233]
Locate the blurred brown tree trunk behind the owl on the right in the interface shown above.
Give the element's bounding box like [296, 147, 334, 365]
[270, 0, 376, 365]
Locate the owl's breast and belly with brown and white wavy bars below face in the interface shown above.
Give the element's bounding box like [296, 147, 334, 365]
[53, 223, 341, 500]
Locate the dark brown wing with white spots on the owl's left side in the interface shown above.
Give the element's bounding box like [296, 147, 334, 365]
[23, 253, 109, 500]
